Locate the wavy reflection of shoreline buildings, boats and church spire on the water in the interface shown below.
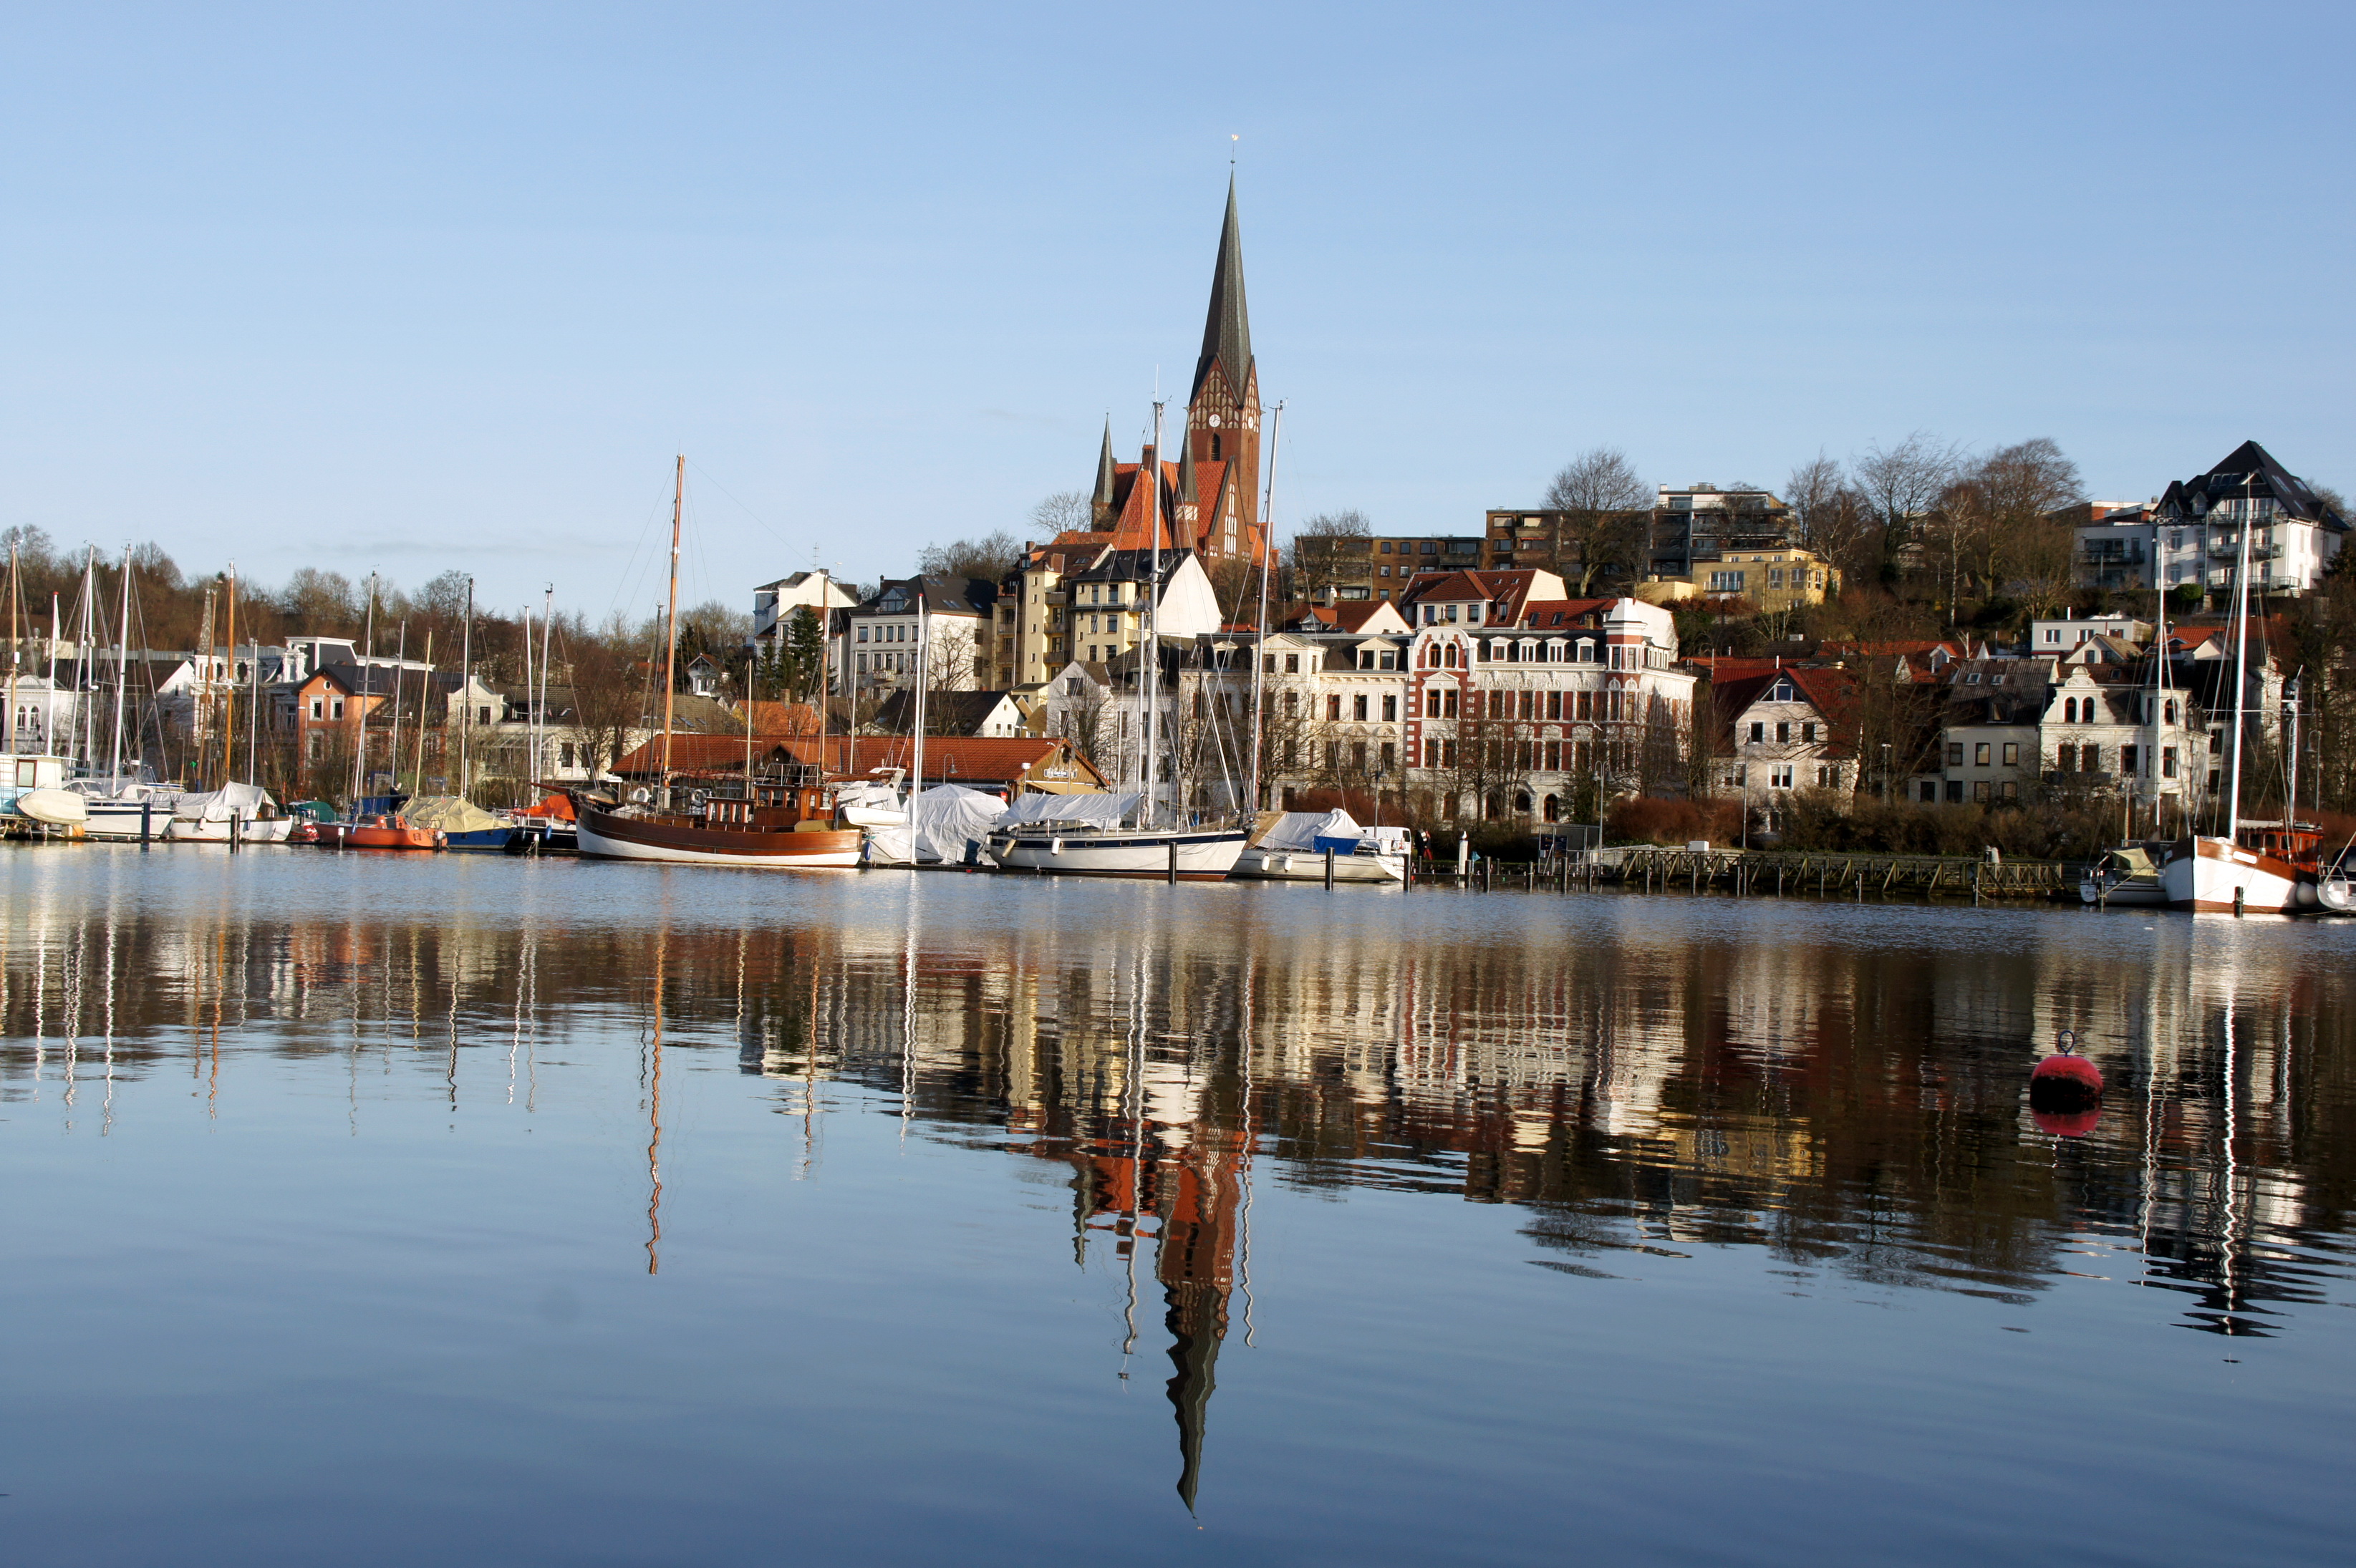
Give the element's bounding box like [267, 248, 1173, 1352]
[0, 876, 2356, 1507]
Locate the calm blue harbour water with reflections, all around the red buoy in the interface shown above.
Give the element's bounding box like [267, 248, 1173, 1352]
[0, 845, 2356, 1563]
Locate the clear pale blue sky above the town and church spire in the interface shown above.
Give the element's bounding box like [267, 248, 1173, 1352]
[0, 2, 2356, 617]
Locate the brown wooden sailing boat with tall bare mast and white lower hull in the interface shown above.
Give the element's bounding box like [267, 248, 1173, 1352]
[572, 457, 860, 868]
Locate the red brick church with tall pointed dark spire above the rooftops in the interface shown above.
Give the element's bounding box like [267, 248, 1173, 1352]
[1088, 177, 1260, 563]
